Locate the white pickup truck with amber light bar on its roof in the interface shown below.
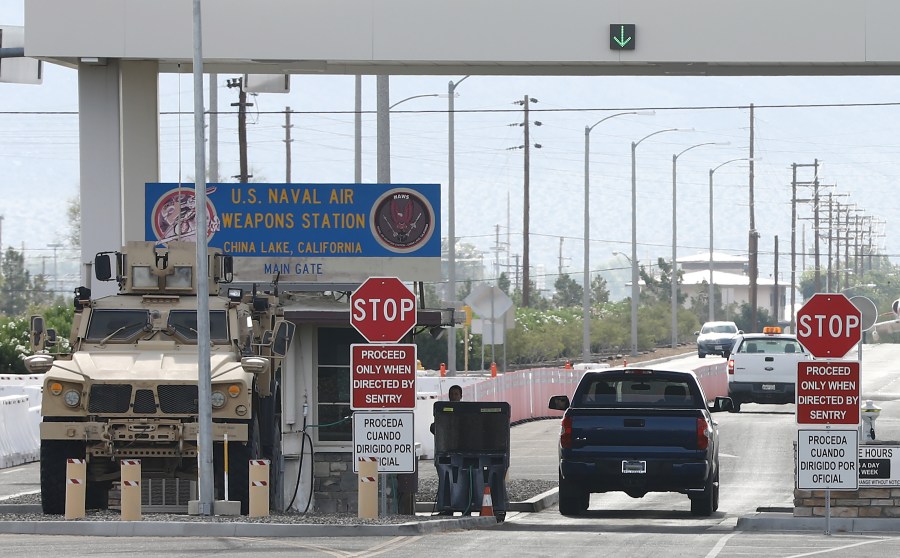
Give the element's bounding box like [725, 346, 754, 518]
[726, 327, 813, 412]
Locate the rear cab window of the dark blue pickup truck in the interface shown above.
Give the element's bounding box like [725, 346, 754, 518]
[574, 376, 701, 409]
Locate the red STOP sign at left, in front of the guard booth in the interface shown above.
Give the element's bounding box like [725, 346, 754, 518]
[350, 277, 416, 343]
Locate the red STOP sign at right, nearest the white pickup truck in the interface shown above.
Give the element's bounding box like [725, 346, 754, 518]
[797, 293, 862, 358]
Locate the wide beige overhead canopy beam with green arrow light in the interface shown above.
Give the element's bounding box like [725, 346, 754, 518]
[25, 0, 900, 75]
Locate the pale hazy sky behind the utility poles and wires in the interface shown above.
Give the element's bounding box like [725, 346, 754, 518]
[0, 0, 900, 300]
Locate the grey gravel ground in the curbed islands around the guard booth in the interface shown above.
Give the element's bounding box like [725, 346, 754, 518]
[0, 479, 557, 525]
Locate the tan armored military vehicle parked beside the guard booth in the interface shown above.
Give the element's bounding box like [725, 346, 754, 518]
[26, 242, 294, 514]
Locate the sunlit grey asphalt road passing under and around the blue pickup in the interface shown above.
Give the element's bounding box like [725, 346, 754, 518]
[0, 346, 900, 558]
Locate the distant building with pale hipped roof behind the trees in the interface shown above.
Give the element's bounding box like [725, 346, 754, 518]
[678, 252, 789, 325]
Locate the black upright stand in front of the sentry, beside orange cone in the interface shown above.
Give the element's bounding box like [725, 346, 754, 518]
[434, 401, 510, 520]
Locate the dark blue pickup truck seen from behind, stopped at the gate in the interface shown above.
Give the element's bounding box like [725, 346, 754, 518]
[549, 368, 732, 516]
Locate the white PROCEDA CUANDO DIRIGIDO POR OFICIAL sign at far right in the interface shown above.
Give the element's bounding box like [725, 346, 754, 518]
[797, 429, 859, 490]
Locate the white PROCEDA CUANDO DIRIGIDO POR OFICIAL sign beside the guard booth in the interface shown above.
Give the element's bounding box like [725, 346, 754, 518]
[353, 411, 416, 473]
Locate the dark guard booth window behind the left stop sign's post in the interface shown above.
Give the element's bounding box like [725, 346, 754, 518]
[315, 327, 366, 442]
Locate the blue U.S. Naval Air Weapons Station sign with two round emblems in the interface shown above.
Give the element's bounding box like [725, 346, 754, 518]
[145, 183, 441, 282]
